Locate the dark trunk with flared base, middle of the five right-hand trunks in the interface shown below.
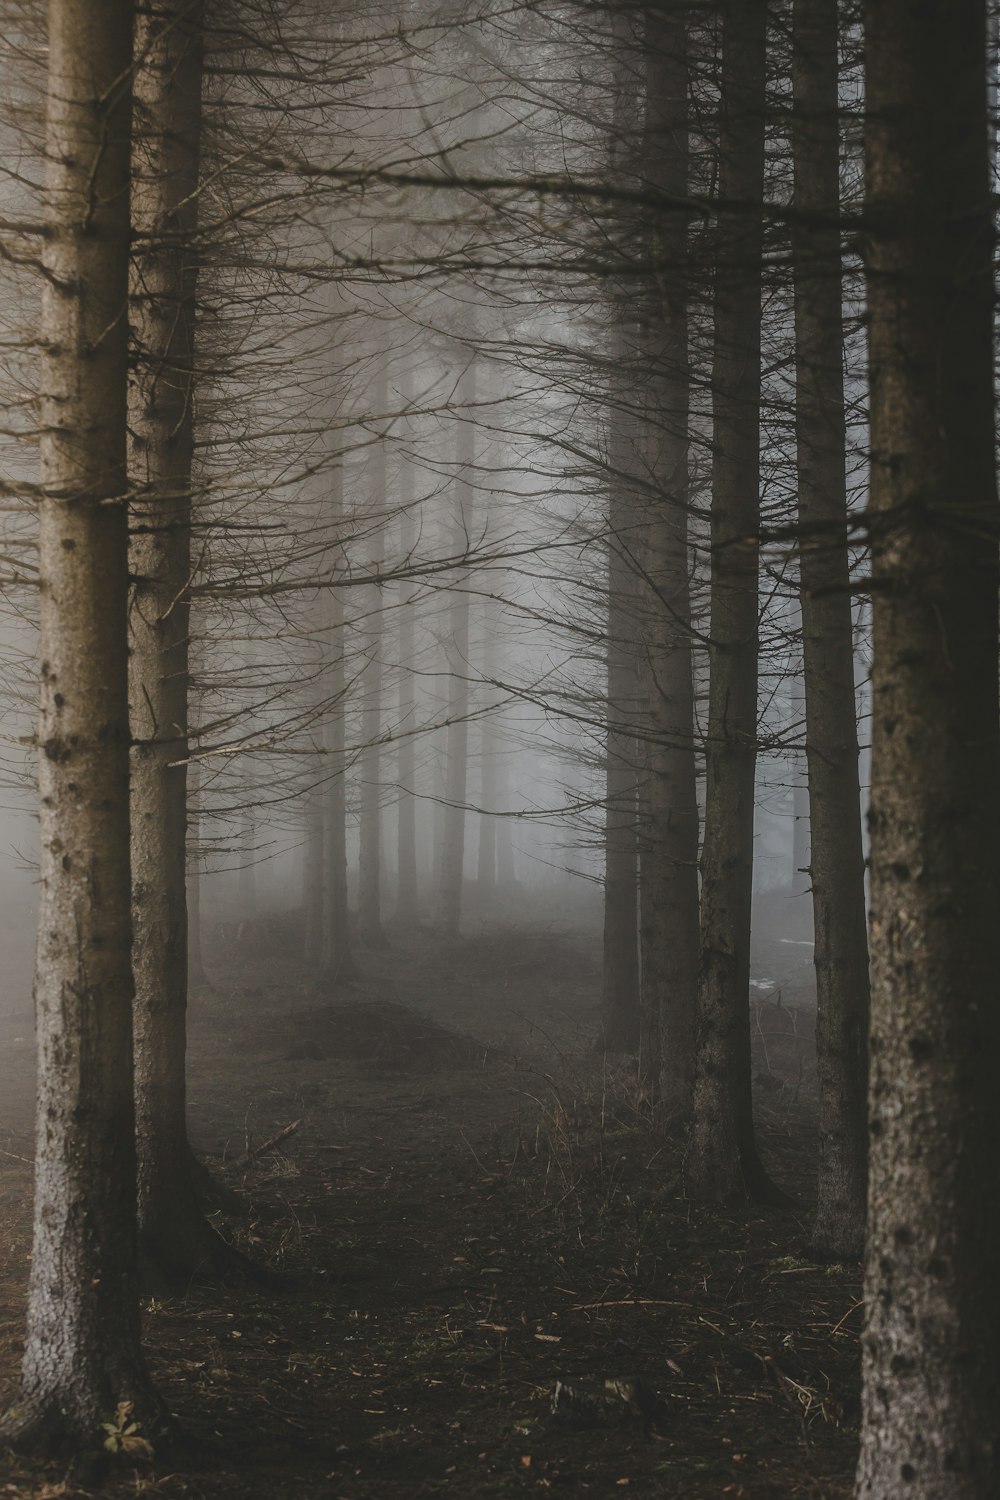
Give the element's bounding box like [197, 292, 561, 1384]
[687, 0, 771, 1202]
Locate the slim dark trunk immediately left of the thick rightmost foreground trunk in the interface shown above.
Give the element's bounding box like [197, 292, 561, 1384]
[792, 0, 868, 1260]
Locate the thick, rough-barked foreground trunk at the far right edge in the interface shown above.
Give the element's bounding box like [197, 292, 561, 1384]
[858, 0, 1000, 1500]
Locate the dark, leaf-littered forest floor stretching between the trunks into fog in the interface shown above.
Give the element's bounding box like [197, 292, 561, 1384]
[0, 912, 861, 1500]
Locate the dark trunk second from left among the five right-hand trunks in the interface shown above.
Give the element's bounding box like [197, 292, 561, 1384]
[639, 9, 699, 1119]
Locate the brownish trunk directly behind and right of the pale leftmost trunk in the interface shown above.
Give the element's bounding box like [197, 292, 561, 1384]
[129, 0, 254, 1286]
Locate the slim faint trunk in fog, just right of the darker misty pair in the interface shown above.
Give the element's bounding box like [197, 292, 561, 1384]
[358, 362, 388, 948]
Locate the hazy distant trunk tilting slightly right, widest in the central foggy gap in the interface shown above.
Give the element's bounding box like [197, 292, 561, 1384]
[438, 359, 475, 938]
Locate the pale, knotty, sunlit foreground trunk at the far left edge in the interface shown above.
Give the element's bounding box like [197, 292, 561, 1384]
[0, 0, 162, 1446]
